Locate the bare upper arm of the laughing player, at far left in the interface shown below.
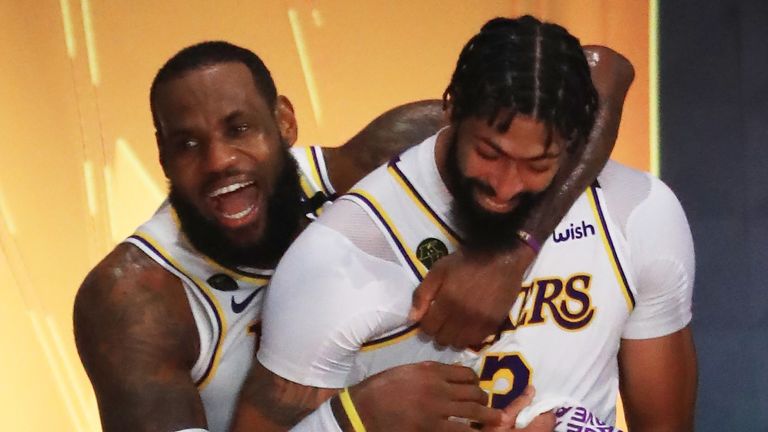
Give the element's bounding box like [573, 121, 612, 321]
[74, 245, 206, 432]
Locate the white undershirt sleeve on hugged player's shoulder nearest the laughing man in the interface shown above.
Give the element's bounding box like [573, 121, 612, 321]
[258, 218, 411, 388]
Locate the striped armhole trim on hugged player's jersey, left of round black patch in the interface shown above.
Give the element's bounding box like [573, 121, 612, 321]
[342, 193, 427, 285]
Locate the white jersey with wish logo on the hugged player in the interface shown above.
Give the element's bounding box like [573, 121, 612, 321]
[340, 146, 635, 424]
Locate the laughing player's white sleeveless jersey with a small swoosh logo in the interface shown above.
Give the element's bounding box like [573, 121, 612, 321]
[125, 147, 333, 432]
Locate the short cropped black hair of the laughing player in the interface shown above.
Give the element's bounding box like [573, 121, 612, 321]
[149, 41, 277, 131]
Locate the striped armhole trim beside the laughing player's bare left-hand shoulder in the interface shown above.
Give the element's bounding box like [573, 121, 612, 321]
[125, 233, 226, 390]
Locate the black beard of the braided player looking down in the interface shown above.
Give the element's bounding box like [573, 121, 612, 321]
[446, 133, 540, 252]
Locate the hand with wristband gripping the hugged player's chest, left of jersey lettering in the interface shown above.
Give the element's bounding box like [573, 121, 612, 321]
[409, 245, 535, 349]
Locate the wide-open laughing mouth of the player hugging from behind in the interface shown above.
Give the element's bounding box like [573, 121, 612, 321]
[208, 181, 261, 228]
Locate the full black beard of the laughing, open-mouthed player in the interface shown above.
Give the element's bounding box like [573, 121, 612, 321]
[168, 142, 303, 267]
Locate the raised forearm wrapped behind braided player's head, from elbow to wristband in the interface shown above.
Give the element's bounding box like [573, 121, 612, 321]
[522, 46, 634, 241]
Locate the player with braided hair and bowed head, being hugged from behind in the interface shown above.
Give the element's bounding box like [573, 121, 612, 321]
[236, 16, 696, 432]
